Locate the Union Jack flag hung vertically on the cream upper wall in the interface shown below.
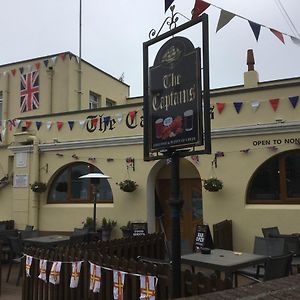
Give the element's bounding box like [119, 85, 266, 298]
[20, 71, 40, 112]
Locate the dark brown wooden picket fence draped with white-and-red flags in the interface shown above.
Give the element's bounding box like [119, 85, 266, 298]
[22, 234, 231, 300]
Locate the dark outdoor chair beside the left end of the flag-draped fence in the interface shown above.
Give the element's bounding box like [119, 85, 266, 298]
[6, 237, 23, 285]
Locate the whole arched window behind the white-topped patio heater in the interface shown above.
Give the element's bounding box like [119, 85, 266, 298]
[48, 162, 113, 203]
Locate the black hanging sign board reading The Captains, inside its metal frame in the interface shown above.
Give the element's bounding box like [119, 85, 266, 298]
[148, 37, 203, 151]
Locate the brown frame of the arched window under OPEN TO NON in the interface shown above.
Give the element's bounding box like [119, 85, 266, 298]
[246, 150, 300, 205]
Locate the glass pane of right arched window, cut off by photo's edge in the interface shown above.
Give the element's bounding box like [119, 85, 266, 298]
[285, 153, 300, 198]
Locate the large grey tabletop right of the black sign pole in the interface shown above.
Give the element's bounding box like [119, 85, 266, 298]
[181, 249, 268, 279]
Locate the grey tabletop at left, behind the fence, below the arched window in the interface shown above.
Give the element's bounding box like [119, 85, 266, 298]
[23, 235, 70, 248]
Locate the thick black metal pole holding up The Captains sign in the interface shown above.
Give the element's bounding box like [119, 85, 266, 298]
[169, 151, 183, 298]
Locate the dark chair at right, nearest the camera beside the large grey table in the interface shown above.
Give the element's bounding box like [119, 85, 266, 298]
[239, 253, 293, 282]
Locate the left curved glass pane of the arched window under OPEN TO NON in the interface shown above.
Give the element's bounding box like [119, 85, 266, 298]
[250, 157, 280, 200]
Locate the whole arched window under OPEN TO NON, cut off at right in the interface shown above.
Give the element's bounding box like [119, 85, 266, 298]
[247, 150, 300, 204]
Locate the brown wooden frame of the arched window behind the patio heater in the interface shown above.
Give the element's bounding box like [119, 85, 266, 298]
[47, 162, 113, 204]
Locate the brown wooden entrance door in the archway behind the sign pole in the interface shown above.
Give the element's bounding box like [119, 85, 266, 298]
[157, 179, 203, 247]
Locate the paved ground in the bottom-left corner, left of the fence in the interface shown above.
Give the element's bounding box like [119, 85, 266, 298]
[0, 264, 22, 300]
